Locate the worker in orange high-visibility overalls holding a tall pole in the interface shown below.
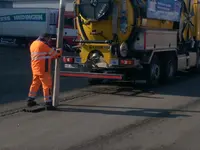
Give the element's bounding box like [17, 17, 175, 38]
[27, 33, 62, 109]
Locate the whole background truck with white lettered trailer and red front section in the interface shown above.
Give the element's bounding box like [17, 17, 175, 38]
[0, 8, 77, 48]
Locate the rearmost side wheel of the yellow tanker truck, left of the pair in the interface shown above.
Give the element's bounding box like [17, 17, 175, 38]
[147, 55, 161, 86]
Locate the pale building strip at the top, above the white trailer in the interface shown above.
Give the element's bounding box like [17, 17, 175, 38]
[10, 0, 74, 11]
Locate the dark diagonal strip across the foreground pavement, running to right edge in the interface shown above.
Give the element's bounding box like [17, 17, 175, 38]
[66, 96, 200, 150]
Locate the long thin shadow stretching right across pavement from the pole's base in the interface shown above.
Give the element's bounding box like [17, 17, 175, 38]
[58, 105, 189, 118]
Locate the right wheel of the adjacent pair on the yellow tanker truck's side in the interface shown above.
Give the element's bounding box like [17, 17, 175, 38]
[160, 55, 177, 83]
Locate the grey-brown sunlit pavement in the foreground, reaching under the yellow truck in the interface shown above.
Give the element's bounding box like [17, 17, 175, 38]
[0, 46, 200, 150]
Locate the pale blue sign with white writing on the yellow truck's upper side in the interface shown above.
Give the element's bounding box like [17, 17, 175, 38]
[147, 0, 182, 22]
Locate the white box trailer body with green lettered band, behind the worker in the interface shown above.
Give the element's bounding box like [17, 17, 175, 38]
[0, 8, 58, 37]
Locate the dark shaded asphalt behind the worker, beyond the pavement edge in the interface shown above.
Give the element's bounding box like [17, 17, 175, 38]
[0, 47, 87, 103]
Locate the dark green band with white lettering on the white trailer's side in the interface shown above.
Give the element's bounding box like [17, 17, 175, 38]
[0, 13, 46, 22]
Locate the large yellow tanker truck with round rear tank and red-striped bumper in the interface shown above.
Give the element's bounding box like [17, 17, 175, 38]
[60, 0, 200, 86]
